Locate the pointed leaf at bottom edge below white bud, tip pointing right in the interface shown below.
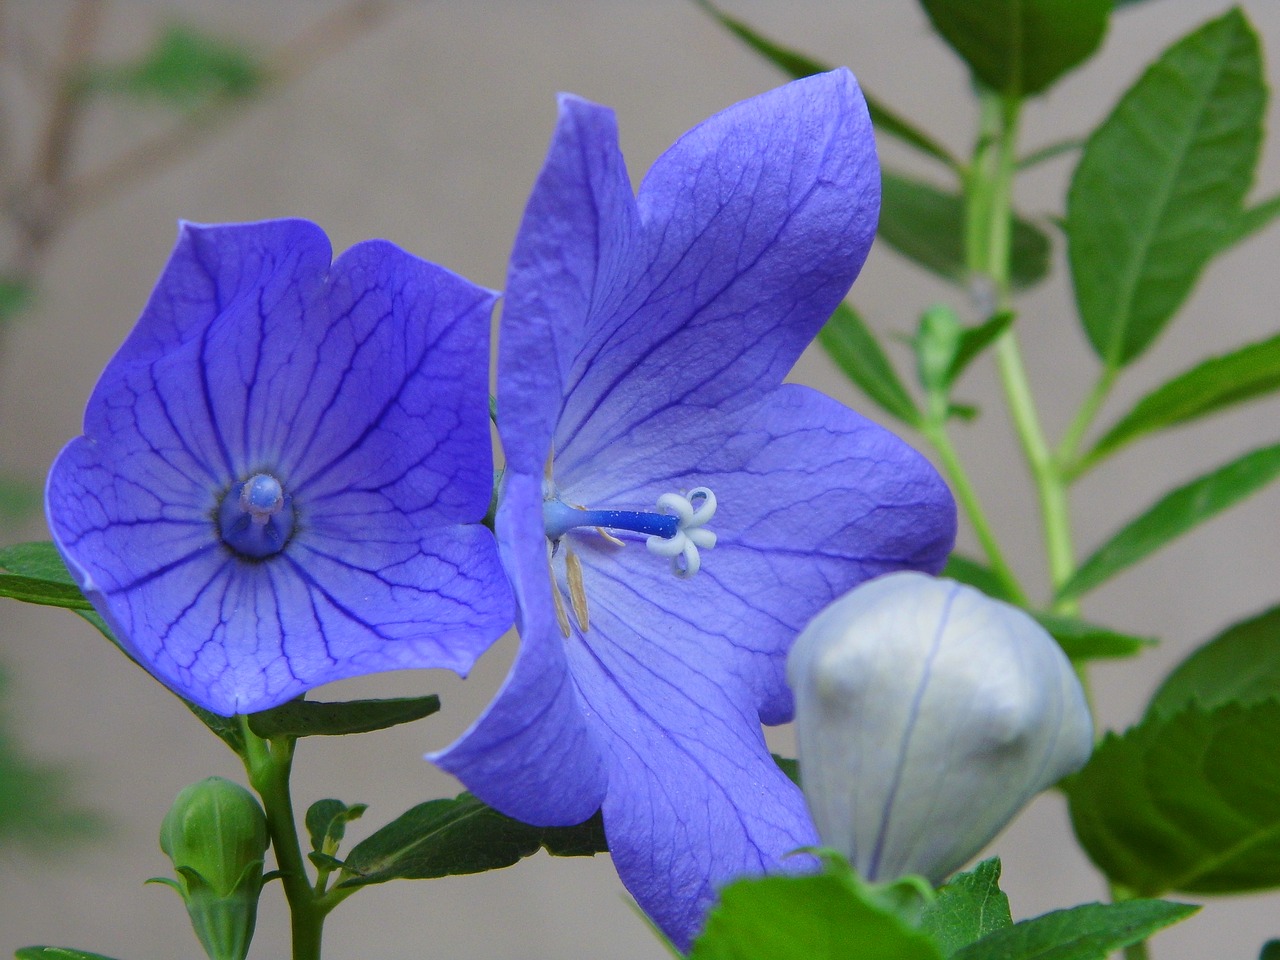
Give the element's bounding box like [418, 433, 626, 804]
[954, 900, 1199, 960]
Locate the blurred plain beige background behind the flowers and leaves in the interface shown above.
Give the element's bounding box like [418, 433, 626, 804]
[0, 0, 1280, 960]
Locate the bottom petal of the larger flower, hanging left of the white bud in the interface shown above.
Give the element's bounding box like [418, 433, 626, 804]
[571, 599, 817, 950]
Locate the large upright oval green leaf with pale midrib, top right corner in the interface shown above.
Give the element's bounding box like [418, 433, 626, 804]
[1066, 10, 1266, 367]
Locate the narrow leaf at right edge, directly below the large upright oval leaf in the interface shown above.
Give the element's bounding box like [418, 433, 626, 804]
[1082, 335, 1280, 467]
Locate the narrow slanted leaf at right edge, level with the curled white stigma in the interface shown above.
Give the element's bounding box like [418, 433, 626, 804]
[1057, 444, 1280, 600]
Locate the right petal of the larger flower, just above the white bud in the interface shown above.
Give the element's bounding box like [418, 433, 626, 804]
[561, 384, 955, 723]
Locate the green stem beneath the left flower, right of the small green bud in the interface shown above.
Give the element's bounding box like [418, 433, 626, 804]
[241, 718, 328, 960]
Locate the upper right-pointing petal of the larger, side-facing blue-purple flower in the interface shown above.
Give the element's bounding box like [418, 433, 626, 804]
[550, 70, 879, 475]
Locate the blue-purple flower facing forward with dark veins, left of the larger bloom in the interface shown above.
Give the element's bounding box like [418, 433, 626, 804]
[46, 220, 512, 714]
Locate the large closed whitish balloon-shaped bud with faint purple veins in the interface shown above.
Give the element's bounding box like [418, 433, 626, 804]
[787, 572, 1093, 883]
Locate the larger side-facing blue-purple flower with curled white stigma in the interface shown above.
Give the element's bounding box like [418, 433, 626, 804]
[430, 70, 955, 946]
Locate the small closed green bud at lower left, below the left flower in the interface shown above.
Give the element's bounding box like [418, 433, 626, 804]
[160, 777, 269, 960]
